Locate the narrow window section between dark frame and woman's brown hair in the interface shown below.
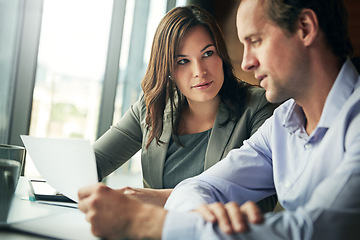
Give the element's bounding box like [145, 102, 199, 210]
[107, 0, 167, 187]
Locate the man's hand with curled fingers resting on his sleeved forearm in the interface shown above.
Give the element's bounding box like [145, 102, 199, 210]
[195, 202, 263, 234]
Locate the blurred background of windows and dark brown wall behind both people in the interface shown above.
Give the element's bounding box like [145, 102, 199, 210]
[0, 0, 360, 187]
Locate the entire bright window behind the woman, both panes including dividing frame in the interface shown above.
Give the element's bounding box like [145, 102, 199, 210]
[25, 0, 184, 183]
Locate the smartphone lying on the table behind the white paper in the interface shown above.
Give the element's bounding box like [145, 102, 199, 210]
[29, 180, 74, 203]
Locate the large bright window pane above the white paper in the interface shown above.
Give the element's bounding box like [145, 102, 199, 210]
[30, 0, 112, 141]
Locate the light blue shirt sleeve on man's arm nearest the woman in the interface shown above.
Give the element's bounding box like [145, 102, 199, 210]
[165, 117, 275, 212]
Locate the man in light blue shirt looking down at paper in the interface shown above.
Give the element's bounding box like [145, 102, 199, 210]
[79, 0, 360, 239]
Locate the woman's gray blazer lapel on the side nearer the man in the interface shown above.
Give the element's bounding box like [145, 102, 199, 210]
[204, 102, 235, 170]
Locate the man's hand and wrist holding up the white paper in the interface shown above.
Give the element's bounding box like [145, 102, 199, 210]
[78, 184, 166, 239]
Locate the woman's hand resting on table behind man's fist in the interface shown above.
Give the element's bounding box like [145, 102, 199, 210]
[119, 187, 172, 207]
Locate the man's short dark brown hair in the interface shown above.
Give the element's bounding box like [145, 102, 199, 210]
[263, 0, 353, 59]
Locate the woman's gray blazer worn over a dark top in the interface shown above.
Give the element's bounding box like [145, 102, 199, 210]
[94, 87, 277, 189]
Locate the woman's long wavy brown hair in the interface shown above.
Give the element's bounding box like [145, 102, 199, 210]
[141, 5, 249, 148]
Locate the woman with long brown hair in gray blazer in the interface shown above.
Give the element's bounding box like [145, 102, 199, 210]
[94, 6, 276, 210]
